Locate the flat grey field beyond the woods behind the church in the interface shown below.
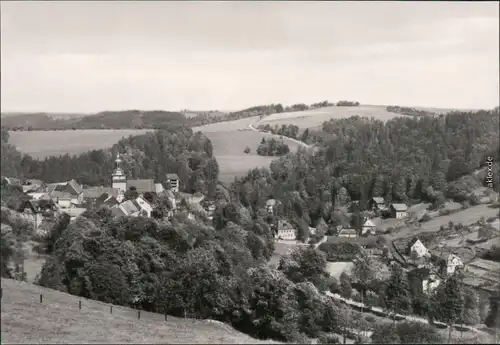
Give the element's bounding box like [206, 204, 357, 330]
[9, 129, 151, 159]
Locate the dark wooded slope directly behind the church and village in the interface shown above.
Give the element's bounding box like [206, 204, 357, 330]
[1, 127, 219, 193]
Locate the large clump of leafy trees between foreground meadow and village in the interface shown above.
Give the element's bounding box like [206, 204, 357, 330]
[31, 204, 376, 341]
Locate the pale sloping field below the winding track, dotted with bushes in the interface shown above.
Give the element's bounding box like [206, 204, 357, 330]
[193, 117, 299, 183]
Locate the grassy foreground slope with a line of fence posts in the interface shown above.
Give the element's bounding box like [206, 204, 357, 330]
[2, 279, 277, 344]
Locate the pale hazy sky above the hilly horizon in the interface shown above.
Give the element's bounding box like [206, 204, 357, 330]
[0, 0, 499, 113]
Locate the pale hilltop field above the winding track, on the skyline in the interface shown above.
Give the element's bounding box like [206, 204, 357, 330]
[258, 105, 404, 129]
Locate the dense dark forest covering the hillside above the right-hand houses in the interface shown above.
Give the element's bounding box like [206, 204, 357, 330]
[232, 111, 500, 230]
